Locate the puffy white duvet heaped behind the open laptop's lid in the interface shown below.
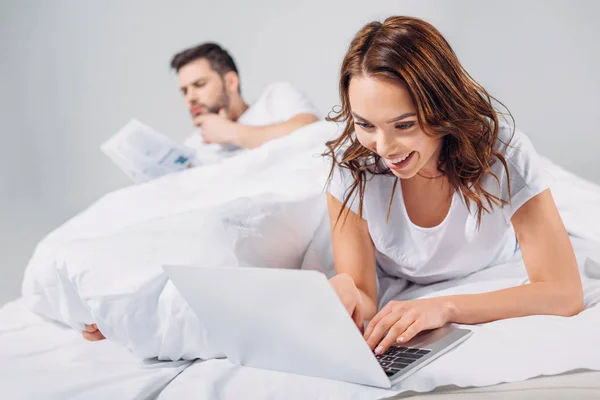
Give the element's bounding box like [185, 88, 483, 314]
[23, 122, 337, 360]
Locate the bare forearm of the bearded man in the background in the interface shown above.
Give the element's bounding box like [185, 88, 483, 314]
[232, 113, 319, 149]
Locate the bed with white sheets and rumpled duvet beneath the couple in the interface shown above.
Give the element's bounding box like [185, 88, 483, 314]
[0, 122, 600, 400]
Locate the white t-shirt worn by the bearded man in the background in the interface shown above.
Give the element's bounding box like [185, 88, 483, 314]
[184, 82, 319, 165]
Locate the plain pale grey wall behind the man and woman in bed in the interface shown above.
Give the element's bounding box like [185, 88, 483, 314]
[0, 0, 600, 304]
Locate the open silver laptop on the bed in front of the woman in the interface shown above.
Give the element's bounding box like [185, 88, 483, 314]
[163, 266, 472, 388]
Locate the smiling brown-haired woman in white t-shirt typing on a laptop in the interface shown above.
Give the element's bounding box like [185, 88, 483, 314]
[326, 17, 583, 354]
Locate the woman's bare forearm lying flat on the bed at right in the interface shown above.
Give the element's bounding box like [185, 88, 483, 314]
[439, 282, 583, 324]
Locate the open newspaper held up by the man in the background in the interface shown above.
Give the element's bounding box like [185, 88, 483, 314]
[100, 119, 198, 183]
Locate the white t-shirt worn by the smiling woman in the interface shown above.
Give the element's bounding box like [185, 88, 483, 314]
[328, 124, 551, 296]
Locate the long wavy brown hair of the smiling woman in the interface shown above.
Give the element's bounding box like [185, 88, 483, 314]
[324, 17, 514, 224]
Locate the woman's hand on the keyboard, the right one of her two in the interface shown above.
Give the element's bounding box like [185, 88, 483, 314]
[364, 298, 450, 354]
